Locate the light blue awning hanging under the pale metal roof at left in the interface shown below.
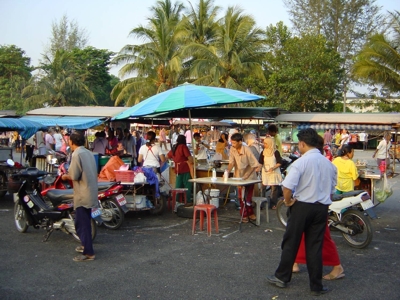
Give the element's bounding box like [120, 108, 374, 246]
[21, 115, 106, 129]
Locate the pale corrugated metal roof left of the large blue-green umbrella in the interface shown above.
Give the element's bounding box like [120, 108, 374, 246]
[26, 106, 129, 118]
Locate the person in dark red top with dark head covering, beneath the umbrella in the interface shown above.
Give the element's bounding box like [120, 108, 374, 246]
[167, 135, 193, 203]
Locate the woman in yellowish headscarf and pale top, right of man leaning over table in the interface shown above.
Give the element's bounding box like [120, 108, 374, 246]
[258, 137, 282, 209]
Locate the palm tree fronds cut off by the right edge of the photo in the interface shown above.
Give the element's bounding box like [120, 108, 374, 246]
[353, 11, 400, 93]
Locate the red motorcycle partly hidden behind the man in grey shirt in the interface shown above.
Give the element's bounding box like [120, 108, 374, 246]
[41, 163, 128, 229]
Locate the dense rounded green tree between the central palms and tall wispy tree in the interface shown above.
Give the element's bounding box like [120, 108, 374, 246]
[263, 23, 343, 111]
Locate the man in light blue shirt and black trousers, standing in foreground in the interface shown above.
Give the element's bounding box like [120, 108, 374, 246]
[267, 128, 337, 295]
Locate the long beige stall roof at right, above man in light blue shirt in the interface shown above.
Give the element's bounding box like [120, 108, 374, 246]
[275, 113, 400, 125]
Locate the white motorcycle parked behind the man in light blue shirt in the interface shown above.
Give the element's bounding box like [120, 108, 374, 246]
[276, 190, 374, 249]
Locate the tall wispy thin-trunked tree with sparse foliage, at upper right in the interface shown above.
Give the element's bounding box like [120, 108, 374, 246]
[284, 0, 384, 106]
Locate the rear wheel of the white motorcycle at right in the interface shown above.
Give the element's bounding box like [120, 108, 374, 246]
[341, 209, 372, 249]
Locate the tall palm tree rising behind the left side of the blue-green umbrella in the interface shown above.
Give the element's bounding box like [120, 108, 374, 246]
[111, 0, 184, 106]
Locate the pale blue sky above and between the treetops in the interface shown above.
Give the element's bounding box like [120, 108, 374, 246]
[0, 0, 400, 92]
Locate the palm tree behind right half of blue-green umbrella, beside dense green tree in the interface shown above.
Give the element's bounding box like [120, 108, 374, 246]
[182, 7, 265, 90]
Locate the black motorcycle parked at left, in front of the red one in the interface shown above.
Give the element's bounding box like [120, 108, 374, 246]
[9, 168, 97, 242]
